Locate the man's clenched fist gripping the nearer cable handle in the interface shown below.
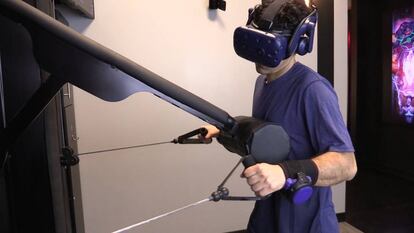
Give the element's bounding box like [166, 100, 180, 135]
[242, 163, 286, 197]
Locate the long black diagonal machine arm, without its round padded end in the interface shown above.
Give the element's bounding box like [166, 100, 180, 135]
[0, 0, 235, 147]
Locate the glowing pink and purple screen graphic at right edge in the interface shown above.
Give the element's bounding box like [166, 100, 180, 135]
[392, 7, 414, 124]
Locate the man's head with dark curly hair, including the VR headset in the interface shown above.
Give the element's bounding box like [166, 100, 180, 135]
[233, 0, 318, 77]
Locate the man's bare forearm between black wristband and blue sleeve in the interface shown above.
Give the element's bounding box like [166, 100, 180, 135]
[312, 152, 357, 186]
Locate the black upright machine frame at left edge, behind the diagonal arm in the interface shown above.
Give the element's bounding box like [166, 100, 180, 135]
[0, 0, 84, 233]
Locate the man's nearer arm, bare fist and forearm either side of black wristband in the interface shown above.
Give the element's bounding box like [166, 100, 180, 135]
[243, 152, 357, 197]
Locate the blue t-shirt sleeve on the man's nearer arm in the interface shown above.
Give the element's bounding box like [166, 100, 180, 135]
[303, 80, 354, 154]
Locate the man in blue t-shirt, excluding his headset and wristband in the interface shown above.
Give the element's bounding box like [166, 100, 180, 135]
[206, 0, 357, 233]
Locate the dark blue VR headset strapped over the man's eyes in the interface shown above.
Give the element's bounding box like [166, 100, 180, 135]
[233, 0, 318, 67]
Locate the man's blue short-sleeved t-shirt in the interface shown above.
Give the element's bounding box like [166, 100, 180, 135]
[248, 62, 354, 233]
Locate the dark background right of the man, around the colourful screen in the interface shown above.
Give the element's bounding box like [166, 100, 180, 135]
[346, 0, 414, 233]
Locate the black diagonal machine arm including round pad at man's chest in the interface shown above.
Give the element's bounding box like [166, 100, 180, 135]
[0, 0, 290, 171]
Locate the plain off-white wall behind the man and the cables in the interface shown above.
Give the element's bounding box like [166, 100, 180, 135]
[57, 0, 347, 233]
